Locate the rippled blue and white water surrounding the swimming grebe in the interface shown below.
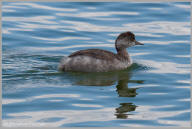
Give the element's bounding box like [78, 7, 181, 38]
[2, 2, 190, 127]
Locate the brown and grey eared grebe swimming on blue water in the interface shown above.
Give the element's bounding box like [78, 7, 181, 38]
[58, 32, 143, 72]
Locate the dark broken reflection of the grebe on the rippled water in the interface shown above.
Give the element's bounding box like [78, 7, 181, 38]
[60, 64, 144, 119]
